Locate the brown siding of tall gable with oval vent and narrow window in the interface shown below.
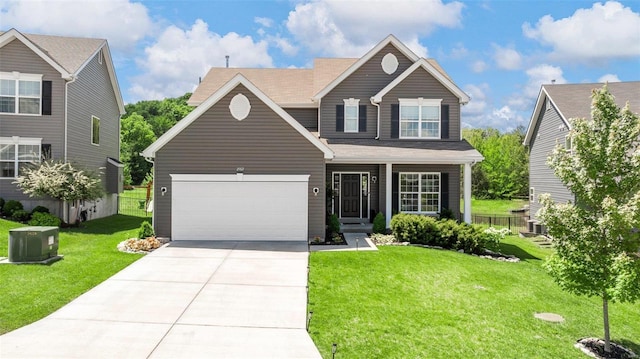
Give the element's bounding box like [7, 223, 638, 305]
[320, 44, 412, 138]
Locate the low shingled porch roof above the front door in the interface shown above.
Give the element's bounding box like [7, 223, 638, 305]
[322, 139, 484, 164]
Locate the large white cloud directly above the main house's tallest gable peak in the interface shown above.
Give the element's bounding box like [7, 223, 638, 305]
[286, 0, 464, 57]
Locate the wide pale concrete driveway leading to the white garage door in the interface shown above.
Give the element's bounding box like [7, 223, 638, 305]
[0, 241, 321, 359]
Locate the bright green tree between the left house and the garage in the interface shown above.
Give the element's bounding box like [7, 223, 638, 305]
[120, 112, 156, 184]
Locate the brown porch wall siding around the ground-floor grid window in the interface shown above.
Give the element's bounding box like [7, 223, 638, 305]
[378, 165, 461, 221]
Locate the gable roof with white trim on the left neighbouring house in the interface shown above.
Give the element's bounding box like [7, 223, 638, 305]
[0, 29, 125, 114]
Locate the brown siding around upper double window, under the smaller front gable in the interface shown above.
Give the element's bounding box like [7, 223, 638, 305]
[380, 68, 460, 141]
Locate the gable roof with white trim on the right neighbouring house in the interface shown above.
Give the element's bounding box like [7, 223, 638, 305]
[523, 81, 640, 146]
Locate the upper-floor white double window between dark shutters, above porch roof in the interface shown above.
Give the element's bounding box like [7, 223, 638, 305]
[399, 98, 442, 138]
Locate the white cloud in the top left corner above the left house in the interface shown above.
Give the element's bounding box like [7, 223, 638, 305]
[0, 0, 154, 51]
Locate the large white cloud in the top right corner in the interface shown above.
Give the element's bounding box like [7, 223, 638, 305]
[522, 1, 640, 63]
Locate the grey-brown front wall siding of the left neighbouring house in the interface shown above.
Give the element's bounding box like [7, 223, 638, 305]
[0, 40, 65, 204]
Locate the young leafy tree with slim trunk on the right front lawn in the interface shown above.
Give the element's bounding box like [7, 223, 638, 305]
[538, 85, 640, 352]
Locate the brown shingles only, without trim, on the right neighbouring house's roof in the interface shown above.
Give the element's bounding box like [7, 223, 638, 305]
[542, 81, 640, 120]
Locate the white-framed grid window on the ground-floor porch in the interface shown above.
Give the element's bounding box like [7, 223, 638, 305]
[399, 172, 440, 213]
